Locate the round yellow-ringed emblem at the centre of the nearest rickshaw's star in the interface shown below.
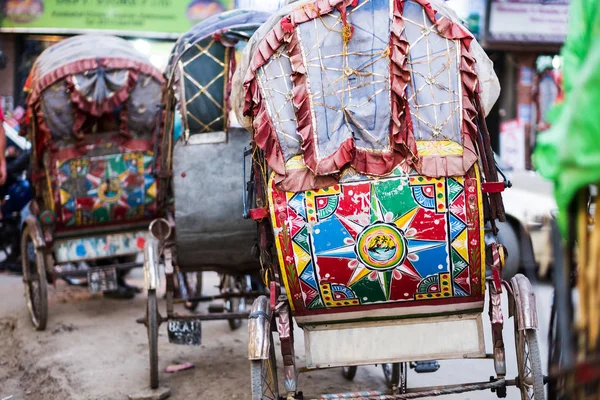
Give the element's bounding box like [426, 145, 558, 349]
[354, 222, 408, 271]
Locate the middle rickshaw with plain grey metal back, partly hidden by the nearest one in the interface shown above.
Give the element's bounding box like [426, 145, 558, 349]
[139, 10, 269, 389]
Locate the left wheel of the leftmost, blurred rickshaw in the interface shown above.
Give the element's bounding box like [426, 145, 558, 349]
[21, 225, 48, 331]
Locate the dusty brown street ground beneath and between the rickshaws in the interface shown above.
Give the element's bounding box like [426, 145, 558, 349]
[0, 271, 552, 400]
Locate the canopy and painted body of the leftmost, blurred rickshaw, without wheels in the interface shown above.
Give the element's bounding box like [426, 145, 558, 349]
[27, 36, 163, 232]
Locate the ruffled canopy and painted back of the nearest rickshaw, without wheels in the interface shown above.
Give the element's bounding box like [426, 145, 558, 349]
[238, 0, 495, 325]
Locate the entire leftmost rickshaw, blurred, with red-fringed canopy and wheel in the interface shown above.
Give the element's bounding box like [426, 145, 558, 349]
[21, 35, 164, 330]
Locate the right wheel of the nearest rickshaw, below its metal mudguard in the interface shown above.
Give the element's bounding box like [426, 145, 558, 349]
[515, 319, 545, 400]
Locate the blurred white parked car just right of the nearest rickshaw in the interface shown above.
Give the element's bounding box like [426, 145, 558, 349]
[496, 156, 556, 279]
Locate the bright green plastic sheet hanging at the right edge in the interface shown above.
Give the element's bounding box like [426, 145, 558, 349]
[534, 0, 600, 234]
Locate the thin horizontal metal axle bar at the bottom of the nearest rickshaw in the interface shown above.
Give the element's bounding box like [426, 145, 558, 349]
[319, 379, 517, 400]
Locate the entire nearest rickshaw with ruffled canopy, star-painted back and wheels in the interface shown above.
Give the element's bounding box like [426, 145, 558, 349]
[234, 0, 544, 400]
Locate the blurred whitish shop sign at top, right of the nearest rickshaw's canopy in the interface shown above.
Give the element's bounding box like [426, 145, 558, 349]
[486, 0, 569, 44]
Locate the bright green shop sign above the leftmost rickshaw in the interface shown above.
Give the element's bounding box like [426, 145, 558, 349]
[0, 0, 233, 38]
